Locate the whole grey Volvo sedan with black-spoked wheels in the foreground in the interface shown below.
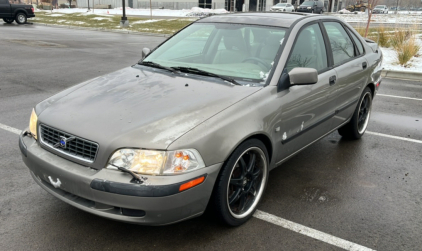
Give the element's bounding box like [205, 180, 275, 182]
[19, 13, 382, 226]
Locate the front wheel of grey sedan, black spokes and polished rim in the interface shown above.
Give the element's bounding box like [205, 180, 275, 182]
[211, 139, 269, 227]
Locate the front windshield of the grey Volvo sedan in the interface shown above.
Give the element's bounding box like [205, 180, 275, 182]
[143, 23, 286, 82]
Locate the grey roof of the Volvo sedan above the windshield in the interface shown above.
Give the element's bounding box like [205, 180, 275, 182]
[197, 12, 317, 28]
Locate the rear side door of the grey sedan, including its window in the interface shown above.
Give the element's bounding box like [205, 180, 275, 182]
[323, 21, 368, 127]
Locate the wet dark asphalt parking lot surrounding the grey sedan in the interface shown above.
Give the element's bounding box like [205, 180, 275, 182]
[0, 23, 422, 250]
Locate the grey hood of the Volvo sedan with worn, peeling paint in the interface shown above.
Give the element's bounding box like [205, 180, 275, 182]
[36, 66, 262, 154]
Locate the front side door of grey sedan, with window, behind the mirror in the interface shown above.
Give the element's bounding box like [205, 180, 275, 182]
[277, 23, 335, 161]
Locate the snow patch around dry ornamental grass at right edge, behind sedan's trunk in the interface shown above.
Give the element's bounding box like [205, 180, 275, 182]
[381, 35, 422, 72]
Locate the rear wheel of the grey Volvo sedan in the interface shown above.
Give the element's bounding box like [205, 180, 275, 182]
[338, 87, 372, 139]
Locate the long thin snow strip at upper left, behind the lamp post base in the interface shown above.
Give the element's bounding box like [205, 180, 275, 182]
[38, 7, 228, 17]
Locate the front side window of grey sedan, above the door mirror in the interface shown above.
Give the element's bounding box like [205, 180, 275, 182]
[286, 24, 328, 71]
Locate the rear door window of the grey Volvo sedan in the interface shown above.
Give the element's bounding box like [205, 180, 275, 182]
[324, 22, 355, 65]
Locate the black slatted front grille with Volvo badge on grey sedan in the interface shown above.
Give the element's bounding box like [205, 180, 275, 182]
[40, 125, 98, 163]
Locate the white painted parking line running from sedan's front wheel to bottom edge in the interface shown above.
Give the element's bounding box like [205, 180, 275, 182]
[253, 210, 374, 251]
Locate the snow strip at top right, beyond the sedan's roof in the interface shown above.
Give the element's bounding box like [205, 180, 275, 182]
[332, 10, 422, 24]
